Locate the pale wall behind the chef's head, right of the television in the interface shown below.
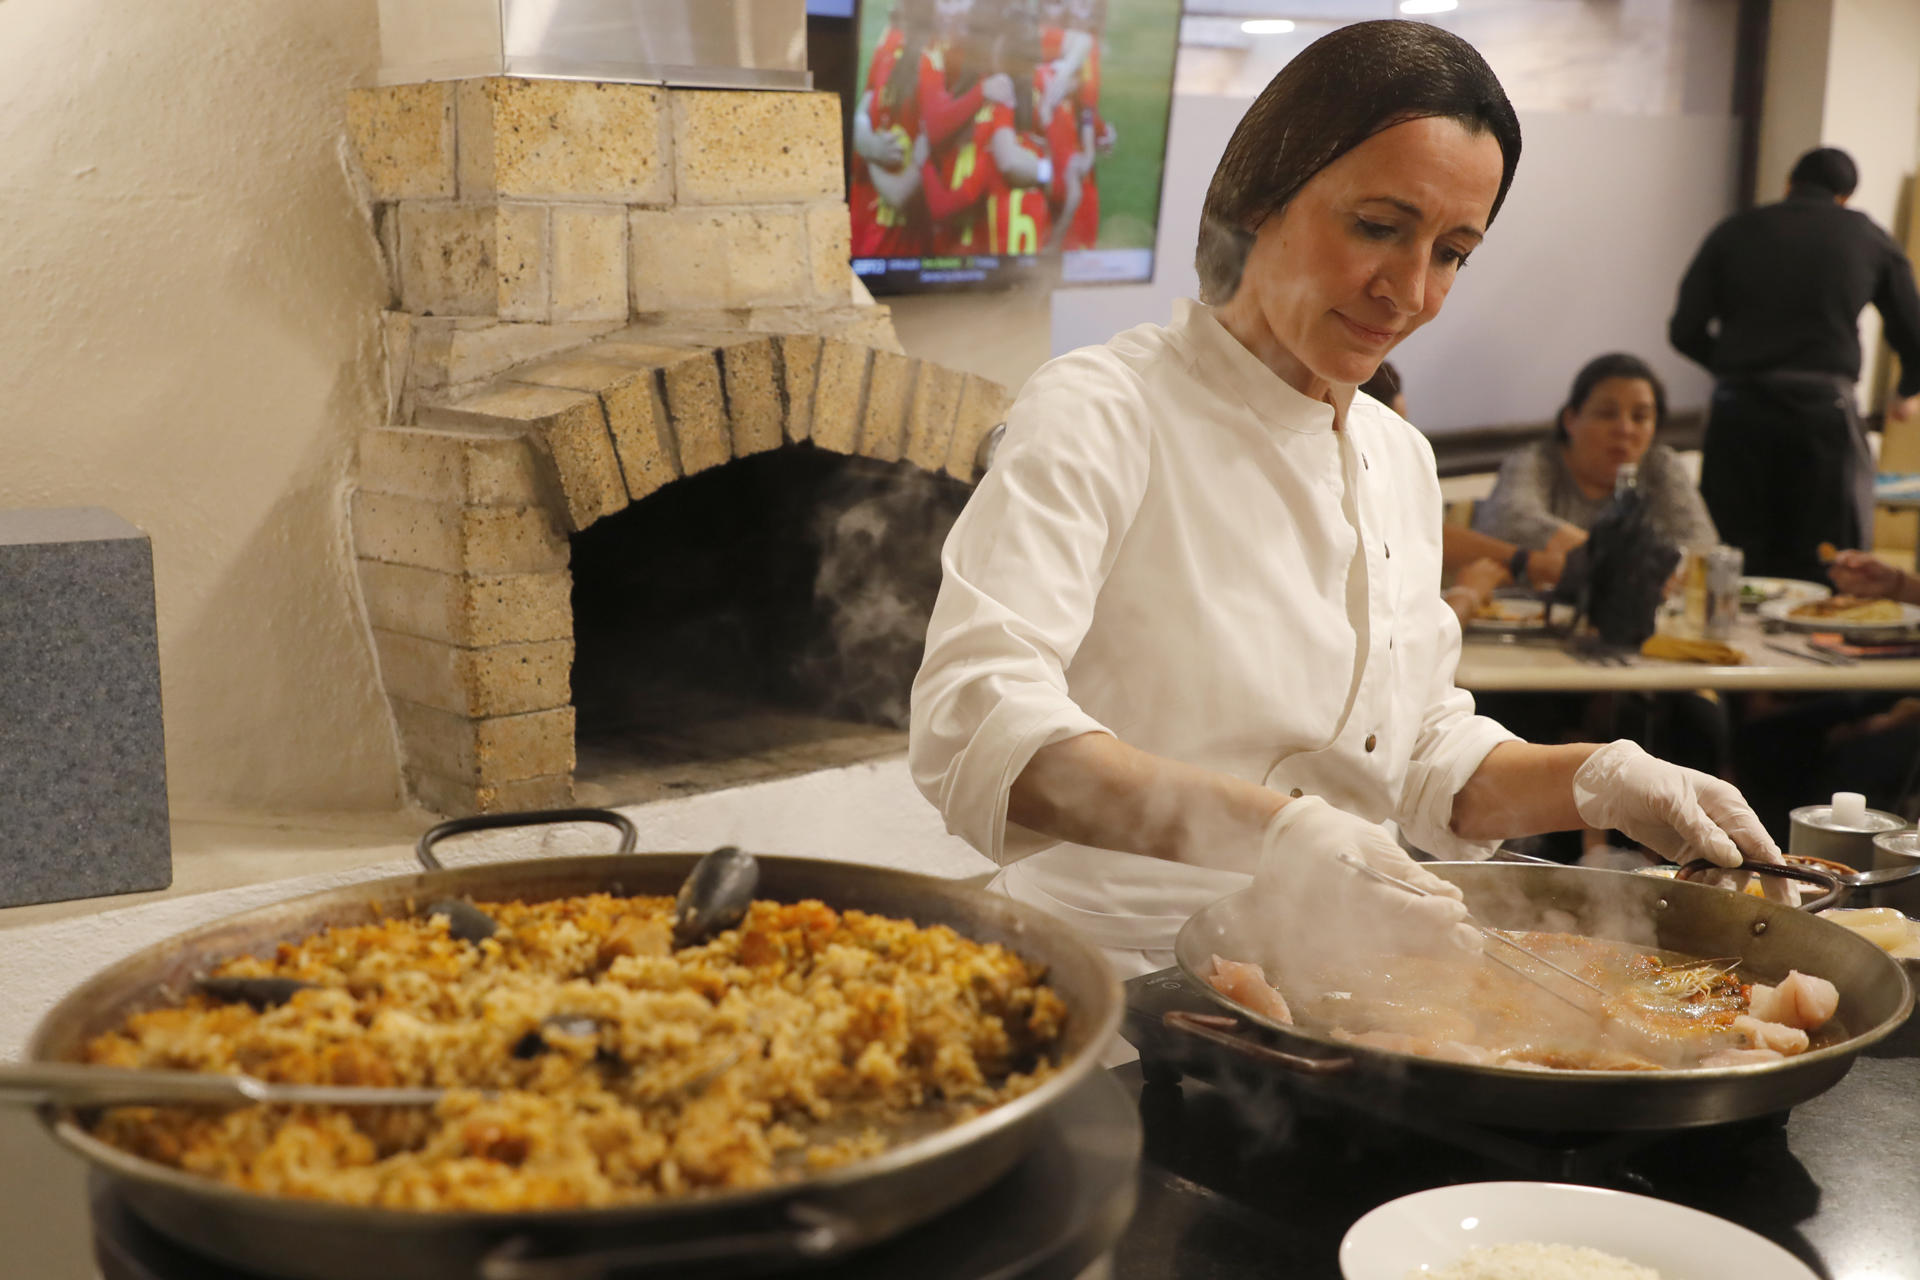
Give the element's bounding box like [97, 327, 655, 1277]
[1052, 96, 1736, 432]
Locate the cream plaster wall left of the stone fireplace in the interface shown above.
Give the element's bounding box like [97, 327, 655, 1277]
[0, 0, 397, 810]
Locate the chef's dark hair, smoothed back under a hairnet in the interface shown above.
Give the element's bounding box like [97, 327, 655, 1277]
[1194, 19, 1521, 303]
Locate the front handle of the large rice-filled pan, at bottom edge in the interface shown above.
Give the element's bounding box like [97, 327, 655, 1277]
[480, 1203, 858, 1280]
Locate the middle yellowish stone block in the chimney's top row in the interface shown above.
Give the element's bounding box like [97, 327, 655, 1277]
[457, 77, 674, 205]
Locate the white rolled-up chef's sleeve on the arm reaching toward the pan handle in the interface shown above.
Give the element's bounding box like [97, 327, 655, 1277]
[1394, 597, 1519, 862]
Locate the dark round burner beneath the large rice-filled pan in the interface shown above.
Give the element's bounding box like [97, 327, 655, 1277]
[90, 1071, 1140, 1280]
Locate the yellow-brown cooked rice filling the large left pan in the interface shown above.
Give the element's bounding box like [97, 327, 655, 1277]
[86, 894, 1066, 1211]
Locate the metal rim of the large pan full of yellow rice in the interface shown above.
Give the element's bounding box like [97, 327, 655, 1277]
[27, 852, 1121, 1232]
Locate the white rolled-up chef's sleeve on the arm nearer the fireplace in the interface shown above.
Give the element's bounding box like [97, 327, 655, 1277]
[906, 349, 1150, 864]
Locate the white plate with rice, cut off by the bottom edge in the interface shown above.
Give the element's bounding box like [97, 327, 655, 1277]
[1340, 1182, 1818, 1280]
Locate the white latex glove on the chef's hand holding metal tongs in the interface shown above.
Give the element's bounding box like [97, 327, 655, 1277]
[1254, 796, 1480, 963]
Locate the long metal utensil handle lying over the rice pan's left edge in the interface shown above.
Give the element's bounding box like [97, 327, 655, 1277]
[0, 1063, 444, 1109]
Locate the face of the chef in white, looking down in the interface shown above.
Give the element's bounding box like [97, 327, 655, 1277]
[1223, 117, 1501, 399]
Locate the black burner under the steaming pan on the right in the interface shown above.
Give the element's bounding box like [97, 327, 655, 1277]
[1121, 969, 1786, 1190]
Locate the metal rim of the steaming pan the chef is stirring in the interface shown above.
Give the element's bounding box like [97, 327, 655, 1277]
[1175, 862, 1914, 1088]
